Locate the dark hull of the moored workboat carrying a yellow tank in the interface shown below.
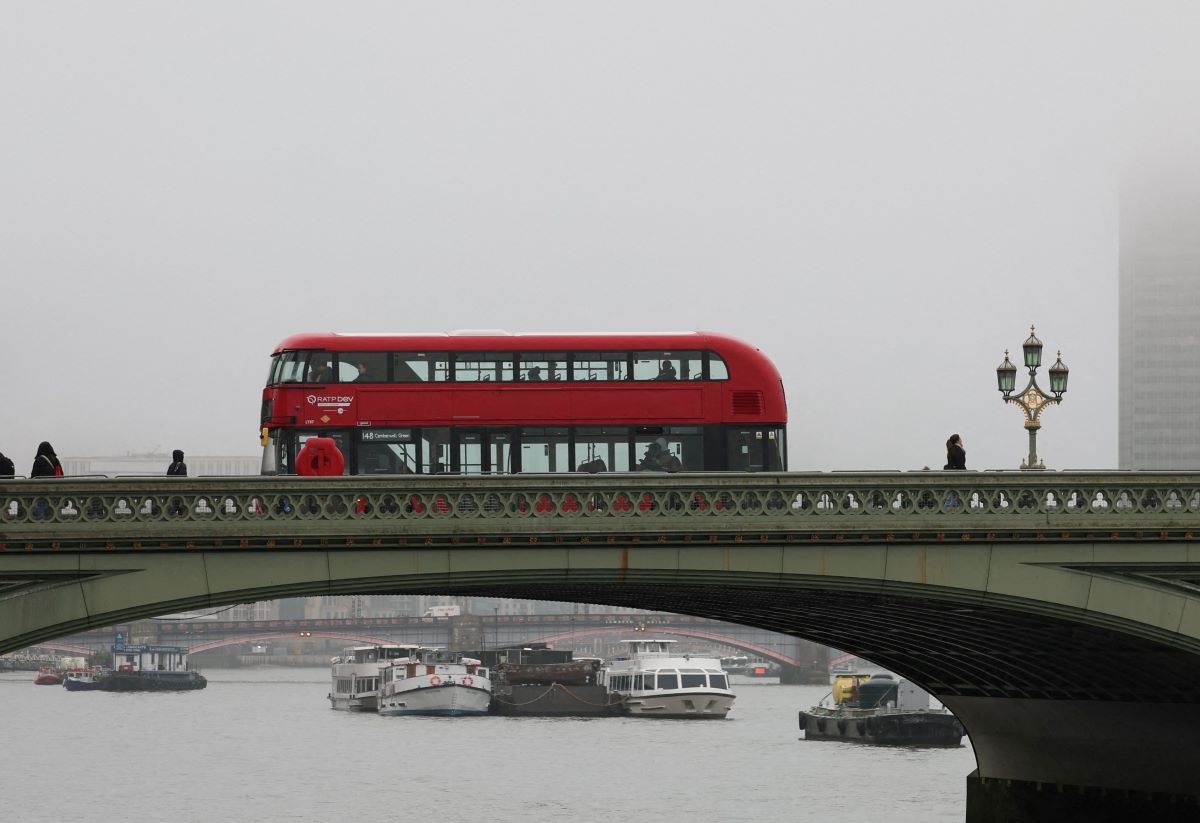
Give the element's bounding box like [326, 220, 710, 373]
[799, 707, 964, 749]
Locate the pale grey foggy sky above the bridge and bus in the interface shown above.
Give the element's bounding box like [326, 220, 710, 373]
[0, 0, 1200, 474]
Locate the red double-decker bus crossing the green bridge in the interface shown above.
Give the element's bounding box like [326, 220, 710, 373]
[262, 332, 787, 475]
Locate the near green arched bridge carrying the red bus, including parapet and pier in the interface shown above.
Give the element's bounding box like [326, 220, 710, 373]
[0, 471, 1200, 821]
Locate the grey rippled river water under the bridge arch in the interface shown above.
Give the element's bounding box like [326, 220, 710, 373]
[0, 668, 974, 823]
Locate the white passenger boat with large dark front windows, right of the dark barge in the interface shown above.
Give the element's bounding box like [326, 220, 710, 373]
[601, 638, 734, 717]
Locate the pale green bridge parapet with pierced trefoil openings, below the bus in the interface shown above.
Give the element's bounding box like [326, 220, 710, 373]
[0, 471, 1200, 551]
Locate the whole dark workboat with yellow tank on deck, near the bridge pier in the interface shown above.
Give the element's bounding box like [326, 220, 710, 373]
[799, 673, 964, 747]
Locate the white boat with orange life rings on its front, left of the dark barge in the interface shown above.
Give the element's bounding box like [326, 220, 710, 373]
[379, 649, 492, 716]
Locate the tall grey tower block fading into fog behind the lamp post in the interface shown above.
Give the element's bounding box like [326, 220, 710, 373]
[1120, 175, 1200, 469]
